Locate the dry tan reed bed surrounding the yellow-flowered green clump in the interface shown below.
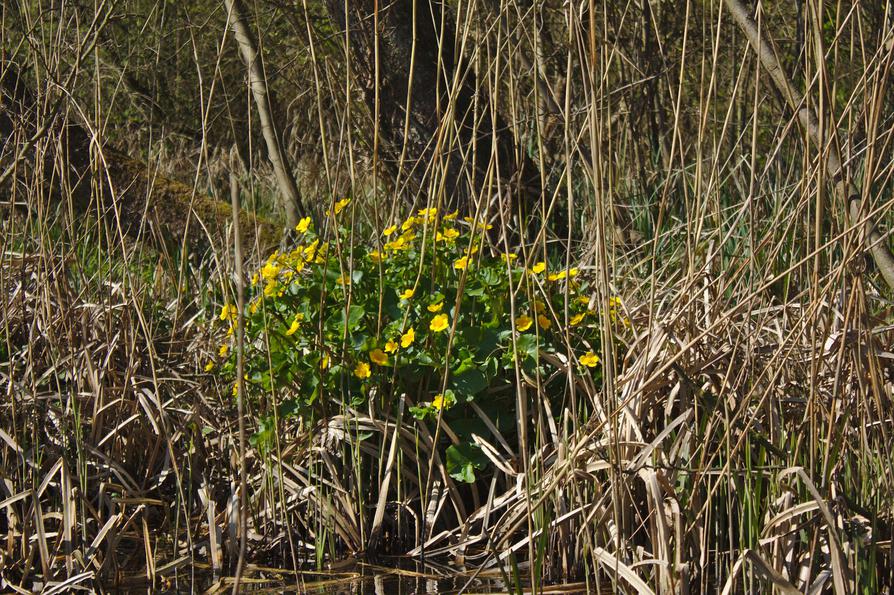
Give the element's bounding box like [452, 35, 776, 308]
[0, 0, 894, 595]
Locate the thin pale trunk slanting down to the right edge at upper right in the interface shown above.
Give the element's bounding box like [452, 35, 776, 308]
[724, 0, 894, 289]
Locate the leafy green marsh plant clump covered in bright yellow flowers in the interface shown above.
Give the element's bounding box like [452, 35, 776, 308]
[209, 199, 629, 482]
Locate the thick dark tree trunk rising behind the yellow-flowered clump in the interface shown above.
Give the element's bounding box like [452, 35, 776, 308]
[326, 0, 540, 219]
